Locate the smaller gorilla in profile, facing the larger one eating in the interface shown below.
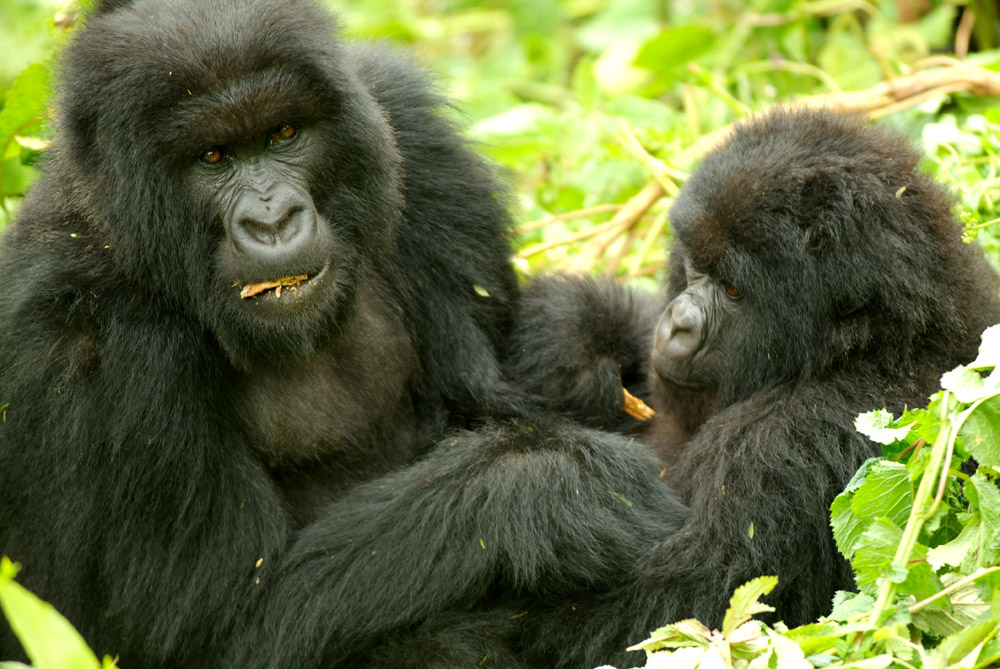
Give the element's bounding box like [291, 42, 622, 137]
[511, 110, 1000, 667]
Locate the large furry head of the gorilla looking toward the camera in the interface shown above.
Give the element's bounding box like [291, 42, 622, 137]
[57, 0, 402, 363]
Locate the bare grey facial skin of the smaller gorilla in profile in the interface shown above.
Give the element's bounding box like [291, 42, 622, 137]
[652, 261, 743, 389]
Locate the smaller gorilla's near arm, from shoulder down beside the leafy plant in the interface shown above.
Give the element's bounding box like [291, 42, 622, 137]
[521, 386, 870, 668]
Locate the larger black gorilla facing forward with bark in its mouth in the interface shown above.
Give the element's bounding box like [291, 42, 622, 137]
[0, 0, 683, 668]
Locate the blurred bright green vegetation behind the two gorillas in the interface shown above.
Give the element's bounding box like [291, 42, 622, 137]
[0, 0, 1000, 281]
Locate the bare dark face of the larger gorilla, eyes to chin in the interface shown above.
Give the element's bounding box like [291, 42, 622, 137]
[187, 121, 332, 315]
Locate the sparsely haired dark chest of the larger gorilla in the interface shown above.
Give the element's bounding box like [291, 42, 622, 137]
[232, 301, 420, 488]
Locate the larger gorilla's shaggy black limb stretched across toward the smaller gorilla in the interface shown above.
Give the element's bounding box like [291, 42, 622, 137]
[250, 420, 686, 666]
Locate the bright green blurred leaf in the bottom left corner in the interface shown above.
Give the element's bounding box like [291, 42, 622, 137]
[0, 556, 116, 669]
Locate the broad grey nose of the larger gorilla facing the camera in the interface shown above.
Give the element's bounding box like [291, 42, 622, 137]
[229, 189, 317, 260]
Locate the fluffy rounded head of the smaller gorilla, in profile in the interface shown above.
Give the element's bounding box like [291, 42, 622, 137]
[652, 109, 992, 404]
